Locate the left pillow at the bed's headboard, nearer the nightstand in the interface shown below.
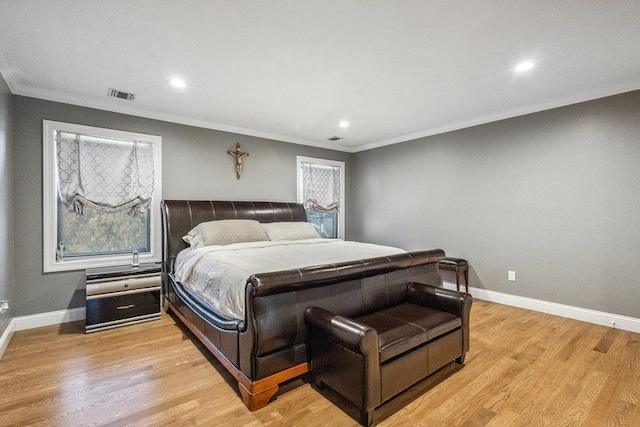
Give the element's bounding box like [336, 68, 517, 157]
[182, 219, 269, 249]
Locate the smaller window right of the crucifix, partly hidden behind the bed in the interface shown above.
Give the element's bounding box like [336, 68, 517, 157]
[297, 157, 345, 239]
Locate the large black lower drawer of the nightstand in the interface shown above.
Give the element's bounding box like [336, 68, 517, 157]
[86, 288, 160, 332]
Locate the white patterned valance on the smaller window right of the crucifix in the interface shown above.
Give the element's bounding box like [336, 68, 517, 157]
[300, 162, 340, 213]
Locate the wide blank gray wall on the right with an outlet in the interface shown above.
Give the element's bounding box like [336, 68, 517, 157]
[347, 91, 640, 318]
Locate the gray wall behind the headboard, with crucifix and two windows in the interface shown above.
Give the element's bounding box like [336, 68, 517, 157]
[11, 96, 352, 316]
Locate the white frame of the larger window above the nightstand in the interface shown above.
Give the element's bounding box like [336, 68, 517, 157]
[42, 120, 162, 273]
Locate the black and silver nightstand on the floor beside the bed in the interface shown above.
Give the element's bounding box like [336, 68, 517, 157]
[85, 263, 161, 333]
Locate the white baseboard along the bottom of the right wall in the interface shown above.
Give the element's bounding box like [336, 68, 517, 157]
[444, 281, 640, 333]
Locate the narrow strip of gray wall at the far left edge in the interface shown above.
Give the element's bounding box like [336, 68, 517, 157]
[0, 75, 15, 335]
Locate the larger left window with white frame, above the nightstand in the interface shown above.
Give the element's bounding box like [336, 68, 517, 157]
[43, 120, 162, 272]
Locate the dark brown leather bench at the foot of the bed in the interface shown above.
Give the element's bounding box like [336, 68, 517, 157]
[305, 283, 472, 425]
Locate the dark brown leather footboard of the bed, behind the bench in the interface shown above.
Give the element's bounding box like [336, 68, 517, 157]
[239, 249, 444, 379]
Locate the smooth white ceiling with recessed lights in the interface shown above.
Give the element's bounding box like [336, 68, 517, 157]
[0, 0, 640, 152]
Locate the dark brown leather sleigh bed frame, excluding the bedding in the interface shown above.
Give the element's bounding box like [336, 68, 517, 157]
[161, 200, 444, 410]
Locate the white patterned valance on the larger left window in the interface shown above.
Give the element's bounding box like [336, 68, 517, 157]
[56, 131, 154, 215]
